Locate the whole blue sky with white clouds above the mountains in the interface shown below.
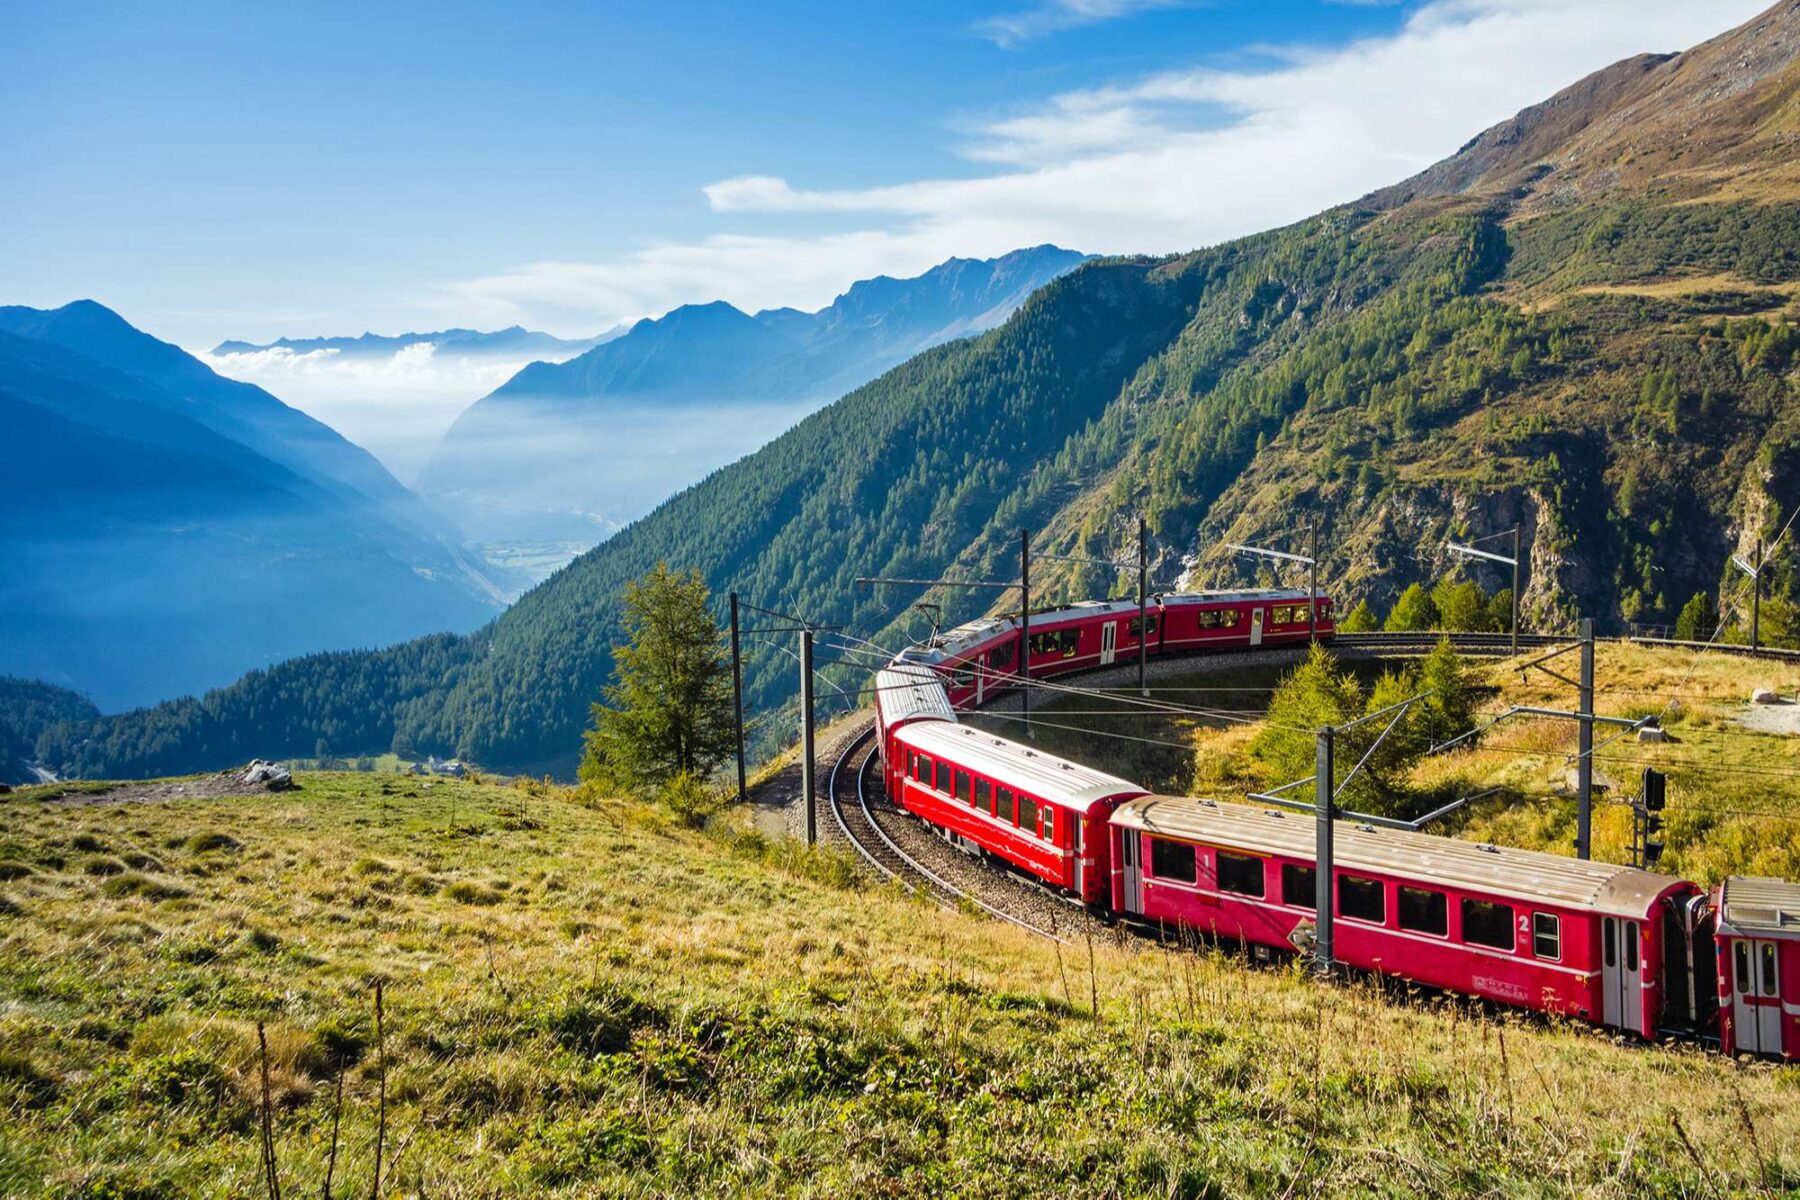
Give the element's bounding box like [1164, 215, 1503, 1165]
[0, 0, 1764, 347]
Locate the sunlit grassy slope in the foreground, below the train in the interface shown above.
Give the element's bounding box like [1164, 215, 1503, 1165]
[0, 774, 1800, 1196]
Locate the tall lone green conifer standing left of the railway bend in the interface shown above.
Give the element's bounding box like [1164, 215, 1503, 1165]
[581, 563, 736, 792]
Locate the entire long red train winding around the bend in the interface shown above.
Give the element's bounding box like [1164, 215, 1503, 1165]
[875, 592, 1800, 1060]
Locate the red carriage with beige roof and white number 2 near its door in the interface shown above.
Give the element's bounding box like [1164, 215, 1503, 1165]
[1111, 797, 1706, 1036]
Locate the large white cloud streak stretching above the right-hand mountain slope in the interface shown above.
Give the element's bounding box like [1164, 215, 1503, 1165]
[445, 0, 1764, 331]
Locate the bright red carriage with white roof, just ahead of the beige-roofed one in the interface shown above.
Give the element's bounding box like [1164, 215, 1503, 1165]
[884, 720, 1145, 903]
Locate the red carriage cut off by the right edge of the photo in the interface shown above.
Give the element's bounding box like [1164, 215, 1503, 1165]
[1714, 874, 1800, 1060]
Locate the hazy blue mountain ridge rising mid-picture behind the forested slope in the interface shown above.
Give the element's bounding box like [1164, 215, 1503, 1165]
[418, 246, 1084, 556]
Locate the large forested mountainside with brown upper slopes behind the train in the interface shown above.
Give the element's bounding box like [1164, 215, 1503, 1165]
[38, 2, 1800, 774]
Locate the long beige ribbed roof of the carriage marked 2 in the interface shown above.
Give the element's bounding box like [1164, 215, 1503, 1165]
[1112, 795, 1681, 919]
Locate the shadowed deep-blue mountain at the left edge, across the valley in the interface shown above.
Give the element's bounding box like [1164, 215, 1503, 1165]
[0, 300, 500, 709]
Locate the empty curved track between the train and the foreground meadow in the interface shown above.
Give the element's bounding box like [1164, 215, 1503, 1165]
[824, 723, 1085, 943]
